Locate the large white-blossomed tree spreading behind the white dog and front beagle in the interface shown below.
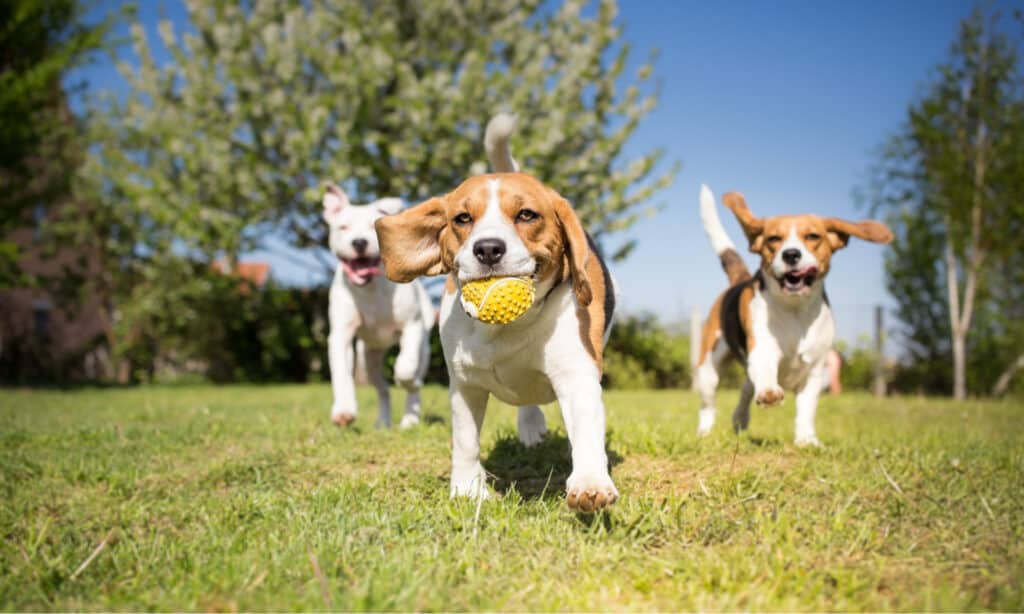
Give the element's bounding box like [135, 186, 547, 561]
[83, 0, 677, 378]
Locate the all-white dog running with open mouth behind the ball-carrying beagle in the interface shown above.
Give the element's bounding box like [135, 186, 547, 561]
[324, 185, 434, 428]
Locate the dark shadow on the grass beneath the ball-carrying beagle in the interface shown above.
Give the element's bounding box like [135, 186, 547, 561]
[483, 433, 623, 500]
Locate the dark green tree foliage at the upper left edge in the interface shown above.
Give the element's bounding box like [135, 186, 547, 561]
[0, 0, 115, 289]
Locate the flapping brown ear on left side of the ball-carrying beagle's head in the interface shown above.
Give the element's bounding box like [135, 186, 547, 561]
[374, 198, 452, 283]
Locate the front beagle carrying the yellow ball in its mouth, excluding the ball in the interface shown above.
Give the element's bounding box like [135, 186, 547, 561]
[377, 117, 618, 512]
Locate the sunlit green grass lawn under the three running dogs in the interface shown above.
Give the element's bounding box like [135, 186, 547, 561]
[0, 386, 1024, 610]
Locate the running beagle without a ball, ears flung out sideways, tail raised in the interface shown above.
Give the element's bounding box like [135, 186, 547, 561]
[695, 186, 892, 445]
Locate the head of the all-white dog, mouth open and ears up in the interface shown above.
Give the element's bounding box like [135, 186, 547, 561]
[324, 185, 401, 286]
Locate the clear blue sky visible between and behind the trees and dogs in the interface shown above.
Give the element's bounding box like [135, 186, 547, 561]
[70, 0, 1017, 340]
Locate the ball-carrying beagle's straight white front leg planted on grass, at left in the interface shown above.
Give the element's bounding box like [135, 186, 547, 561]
[450, 383, 490, 498]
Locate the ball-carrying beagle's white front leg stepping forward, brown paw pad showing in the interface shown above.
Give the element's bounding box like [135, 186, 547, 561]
[552, 372, 618, 513]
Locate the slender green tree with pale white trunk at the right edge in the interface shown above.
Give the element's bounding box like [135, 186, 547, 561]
[870, 9, 1024, 399]
